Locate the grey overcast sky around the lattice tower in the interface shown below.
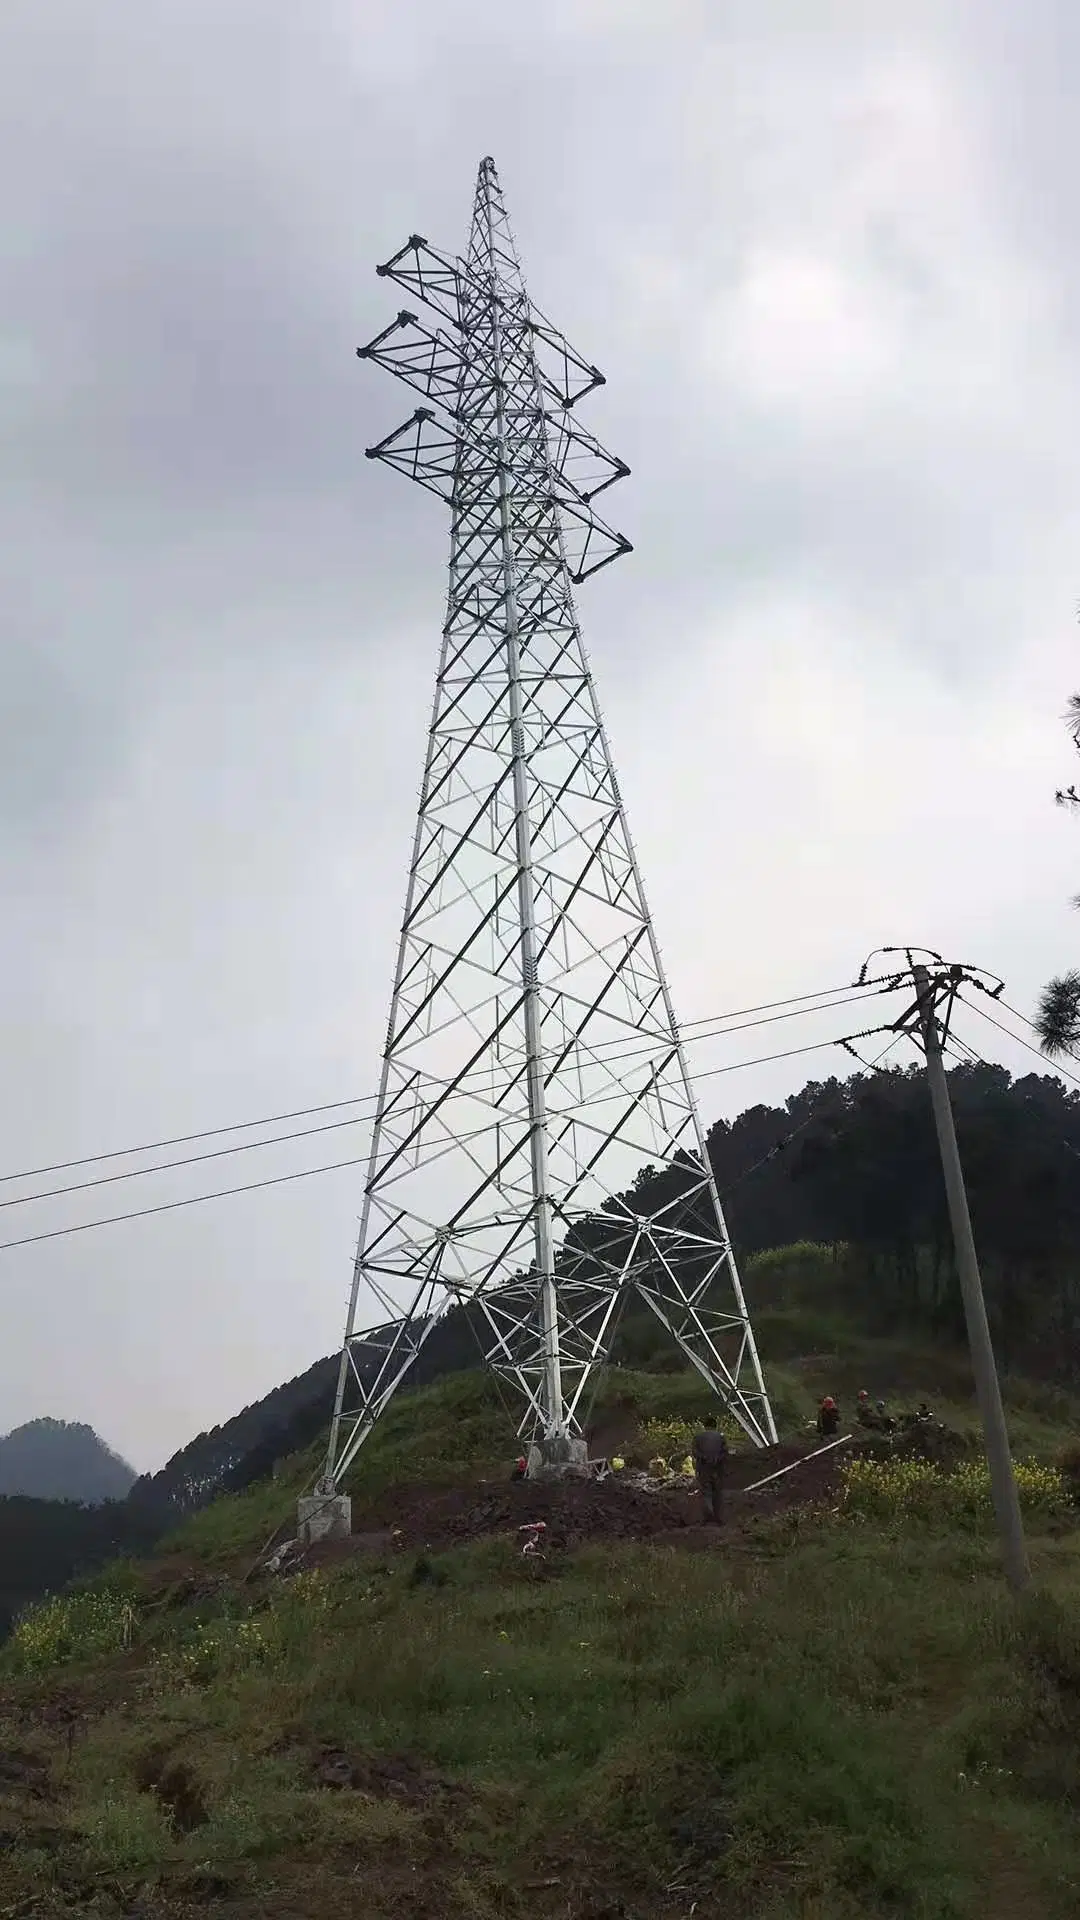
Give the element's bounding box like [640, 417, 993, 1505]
[0, 0, 1080, 1469]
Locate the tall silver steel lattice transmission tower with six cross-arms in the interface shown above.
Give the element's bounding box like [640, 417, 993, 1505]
[321, 159, 776, 1492]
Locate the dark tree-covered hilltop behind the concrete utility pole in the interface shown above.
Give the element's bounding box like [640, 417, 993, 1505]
[709, 1064, 1080, 1379]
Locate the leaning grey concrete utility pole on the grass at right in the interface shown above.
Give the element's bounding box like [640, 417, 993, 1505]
[911, 966, 1032, 1594]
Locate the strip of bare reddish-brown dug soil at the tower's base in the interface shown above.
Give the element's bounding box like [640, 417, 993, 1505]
[313, 1444, 849, 1559]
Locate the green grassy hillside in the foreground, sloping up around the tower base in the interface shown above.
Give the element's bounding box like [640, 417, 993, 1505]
[0, 1308, 1080, 1920]
